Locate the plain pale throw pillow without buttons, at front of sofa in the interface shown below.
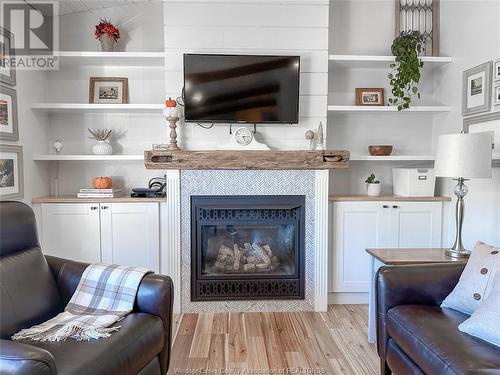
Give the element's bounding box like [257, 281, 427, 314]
[458, 272, 500, 347]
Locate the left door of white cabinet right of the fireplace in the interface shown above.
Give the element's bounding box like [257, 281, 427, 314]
[333, 202, 390, 293]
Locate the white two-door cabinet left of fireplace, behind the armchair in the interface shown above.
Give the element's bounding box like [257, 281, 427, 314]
[40, 202, 160, 272]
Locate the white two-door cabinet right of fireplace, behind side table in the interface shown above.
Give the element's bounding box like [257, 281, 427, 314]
[331, 201, 442, 293]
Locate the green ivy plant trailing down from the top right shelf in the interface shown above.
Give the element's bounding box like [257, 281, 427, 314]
[388, 31, 425, 111]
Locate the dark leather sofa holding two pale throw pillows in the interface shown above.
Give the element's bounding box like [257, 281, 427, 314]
[376, 263, 500, 375]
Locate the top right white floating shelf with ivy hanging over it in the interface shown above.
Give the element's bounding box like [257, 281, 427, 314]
[329, 55, 453, 69]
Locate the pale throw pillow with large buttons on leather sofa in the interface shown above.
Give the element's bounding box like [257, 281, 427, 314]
[441, 242, 500, 315]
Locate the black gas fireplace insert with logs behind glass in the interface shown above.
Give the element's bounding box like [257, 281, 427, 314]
[191, 195, 305, 301]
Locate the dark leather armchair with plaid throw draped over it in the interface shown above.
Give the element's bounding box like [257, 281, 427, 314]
[0, 202, 173, 375]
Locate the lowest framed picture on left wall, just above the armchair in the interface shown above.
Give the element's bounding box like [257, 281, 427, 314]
[0, 145, 24, 199]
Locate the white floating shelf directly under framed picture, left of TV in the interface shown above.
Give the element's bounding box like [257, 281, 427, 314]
[31, 103, 165, 115]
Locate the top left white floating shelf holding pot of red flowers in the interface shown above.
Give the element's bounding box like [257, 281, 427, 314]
[59, 51, 165, 67]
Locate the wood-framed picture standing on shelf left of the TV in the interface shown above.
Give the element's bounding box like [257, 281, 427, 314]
[89, 77, 128, 104]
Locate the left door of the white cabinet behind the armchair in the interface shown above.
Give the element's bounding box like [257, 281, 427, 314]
[41, 203, 101, 263]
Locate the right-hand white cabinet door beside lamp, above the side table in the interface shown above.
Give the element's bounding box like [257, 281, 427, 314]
[389, 202, 443, 248]
